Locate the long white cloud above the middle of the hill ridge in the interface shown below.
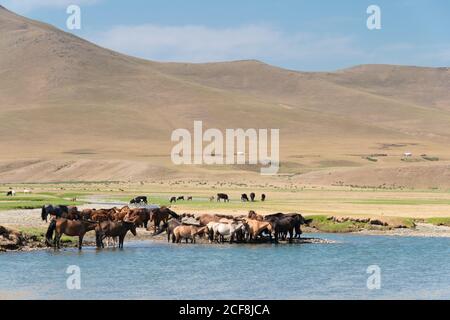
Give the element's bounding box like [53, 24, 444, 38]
[90, 24, 363, 69]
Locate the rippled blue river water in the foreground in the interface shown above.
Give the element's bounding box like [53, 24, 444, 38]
[0, 234, 450, 299]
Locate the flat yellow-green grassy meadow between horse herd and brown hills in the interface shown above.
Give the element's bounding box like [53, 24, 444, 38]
[0, 181, 450, 232]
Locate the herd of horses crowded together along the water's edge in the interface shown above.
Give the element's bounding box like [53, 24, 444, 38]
[41, 205, 310, 250]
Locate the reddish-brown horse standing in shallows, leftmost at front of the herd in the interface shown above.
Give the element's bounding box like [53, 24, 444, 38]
[46, 218, 98, 250]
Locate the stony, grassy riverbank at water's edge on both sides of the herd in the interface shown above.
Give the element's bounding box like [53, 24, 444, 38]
[0, 203, 450, 251]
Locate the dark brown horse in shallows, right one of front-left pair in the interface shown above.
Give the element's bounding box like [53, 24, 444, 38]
[95, 221, 136, 249]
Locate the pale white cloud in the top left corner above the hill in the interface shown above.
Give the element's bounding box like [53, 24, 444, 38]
[0, 0, 100, 13]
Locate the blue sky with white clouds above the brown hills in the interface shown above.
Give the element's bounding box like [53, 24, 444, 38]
[0, 0, 450, 71]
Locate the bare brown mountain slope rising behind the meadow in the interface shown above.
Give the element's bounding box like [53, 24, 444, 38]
[0, 8, 450, 185]
